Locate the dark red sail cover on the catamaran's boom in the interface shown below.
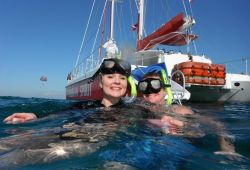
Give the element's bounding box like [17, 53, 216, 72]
[137, 13, 197, 51]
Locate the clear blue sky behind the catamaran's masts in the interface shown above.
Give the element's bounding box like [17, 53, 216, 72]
[0, 0, 250, 99]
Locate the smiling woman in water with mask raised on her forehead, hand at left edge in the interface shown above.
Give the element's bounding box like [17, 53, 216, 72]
[4, 58, 131, 123]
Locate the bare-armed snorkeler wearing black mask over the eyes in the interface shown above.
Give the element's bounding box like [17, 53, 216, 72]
[138, 72, 240, 159]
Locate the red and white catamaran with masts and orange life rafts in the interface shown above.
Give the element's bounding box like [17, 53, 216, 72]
[66, 0, 250, 102]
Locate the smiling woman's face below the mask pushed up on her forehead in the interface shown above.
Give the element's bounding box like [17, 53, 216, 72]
[100, 73, 128, 99]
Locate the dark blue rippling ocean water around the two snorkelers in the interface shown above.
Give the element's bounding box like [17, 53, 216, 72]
[0, 97, 250, 170]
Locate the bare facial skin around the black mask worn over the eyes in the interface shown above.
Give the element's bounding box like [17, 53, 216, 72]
[143, 75, 166, 104]
